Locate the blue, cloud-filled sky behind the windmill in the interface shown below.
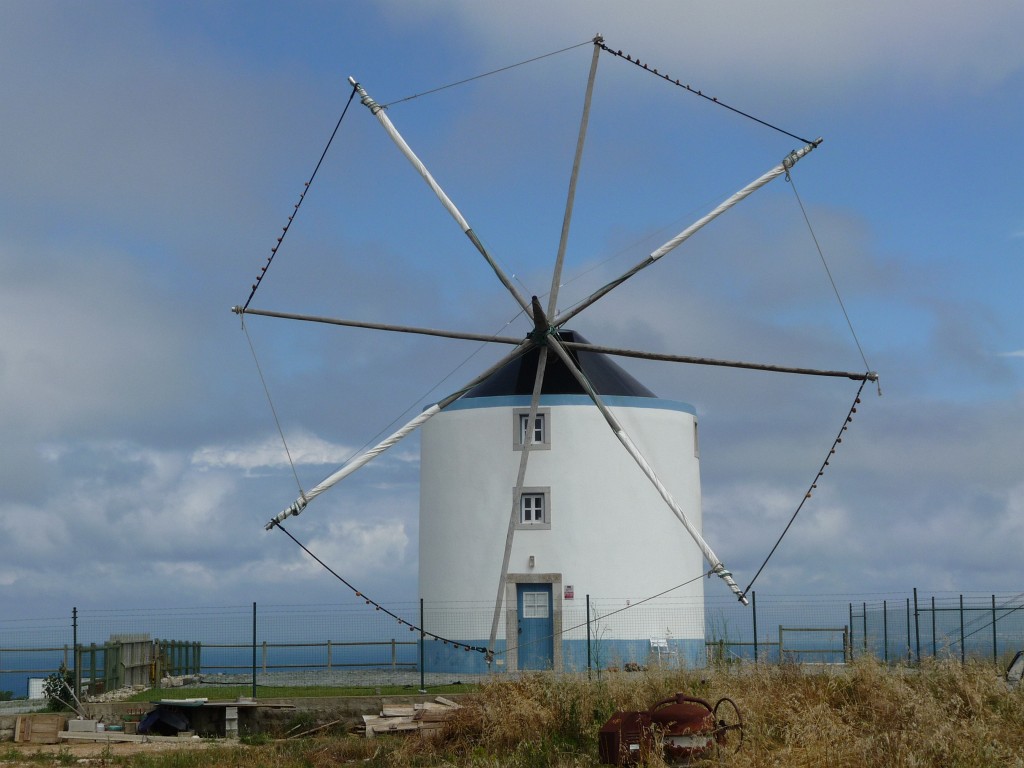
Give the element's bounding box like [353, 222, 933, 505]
[0, 0, 1024, 618]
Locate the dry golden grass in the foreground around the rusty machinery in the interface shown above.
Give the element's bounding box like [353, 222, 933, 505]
[8, 659, 1024, 768]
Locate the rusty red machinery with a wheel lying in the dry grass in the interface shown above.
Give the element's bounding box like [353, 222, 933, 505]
[598, 693, 743, 766]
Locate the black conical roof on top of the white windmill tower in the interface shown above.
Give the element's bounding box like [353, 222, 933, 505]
[463, 331, 657, 398]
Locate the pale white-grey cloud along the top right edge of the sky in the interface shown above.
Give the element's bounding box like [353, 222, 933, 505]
[392, 0, 1024, 103]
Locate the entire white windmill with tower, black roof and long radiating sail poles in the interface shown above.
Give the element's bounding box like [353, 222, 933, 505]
[233, 36, 877, 670]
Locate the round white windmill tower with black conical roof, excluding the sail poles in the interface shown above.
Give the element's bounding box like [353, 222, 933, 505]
[420, 331, 705, 672]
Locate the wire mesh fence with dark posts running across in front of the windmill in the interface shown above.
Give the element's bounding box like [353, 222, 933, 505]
[0, 590, 1024, 698]
